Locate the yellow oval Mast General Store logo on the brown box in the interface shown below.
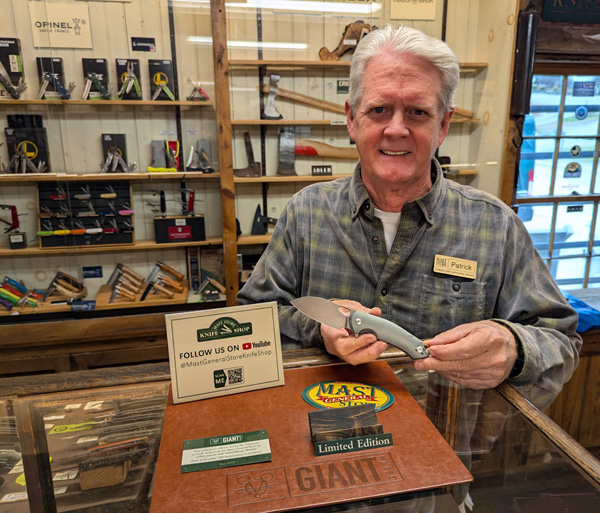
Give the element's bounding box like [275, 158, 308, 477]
[302, 381, 394, 412]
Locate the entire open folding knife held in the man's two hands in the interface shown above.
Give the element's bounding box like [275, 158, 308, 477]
[291, 296, 429, 360]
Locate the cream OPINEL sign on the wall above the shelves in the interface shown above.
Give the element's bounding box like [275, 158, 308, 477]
[29, 2, 92, 48]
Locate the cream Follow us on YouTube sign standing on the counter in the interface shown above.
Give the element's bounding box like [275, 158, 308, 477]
[165, 302, 284, 404]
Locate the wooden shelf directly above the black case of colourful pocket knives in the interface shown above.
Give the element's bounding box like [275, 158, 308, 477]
[0, 171, 220, 183]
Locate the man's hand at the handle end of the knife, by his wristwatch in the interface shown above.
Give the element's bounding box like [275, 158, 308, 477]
[414, 321, 517, 389]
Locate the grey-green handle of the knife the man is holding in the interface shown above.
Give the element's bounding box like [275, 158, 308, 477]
[348, 311, 429, 360]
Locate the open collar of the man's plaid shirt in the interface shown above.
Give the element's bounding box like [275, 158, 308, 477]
[350, 158, 445, 225]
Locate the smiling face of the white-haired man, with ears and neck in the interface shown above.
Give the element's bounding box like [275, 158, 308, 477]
[346, 53, 452, 201]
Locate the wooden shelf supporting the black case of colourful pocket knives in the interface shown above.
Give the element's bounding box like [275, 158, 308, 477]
[0, 237, 223, 257]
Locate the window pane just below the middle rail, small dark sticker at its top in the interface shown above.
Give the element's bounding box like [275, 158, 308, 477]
[552, 203, 594, 257]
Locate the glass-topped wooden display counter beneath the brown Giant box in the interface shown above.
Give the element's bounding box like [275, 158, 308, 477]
[0, 350, 600, 513]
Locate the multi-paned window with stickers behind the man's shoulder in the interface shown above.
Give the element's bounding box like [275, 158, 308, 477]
[516, 73, 600, 289]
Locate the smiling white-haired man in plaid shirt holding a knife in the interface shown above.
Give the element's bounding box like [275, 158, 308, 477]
[238, 26, 581, 405]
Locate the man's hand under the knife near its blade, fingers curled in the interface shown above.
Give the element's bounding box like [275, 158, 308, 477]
[321, 300, 387, 365]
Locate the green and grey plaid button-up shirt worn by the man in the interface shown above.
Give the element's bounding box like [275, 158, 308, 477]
[238, 161, 581, 404]
